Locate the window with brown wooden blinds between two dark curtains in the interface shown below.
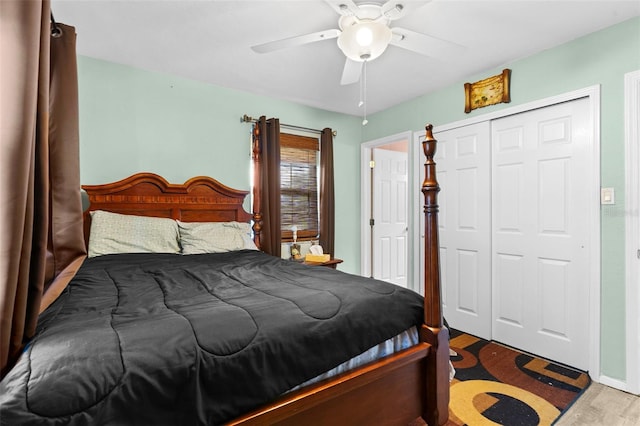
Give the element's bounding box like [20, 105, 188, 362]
[280, 133, 320, 241]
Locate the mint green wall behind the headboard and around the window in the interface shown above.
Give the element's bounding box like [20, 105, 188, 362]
[78, 57, 362, 273]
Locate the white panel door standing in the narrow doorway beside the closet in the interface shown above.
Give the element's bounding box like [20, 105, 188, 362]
[373, 148, 408, 287]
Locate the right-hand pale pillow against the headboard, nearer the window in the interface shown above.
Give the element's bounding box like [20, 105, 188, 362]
[178, 221, 258, 254]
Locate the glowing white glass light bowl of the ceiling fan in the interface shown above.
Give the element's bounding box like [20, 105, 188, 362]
[338, 20, 392, 62]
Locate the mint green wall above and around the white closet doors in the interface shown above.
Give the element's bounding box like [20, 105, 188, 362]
[364, 18, 640, 380]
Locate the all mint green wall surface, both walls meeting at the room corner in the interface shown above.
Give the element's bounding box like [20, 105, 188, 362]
[78, 18, 640, 380]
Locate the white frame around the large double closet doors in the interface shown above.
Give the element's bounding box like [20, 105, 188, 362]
[411, 85, 601, 381]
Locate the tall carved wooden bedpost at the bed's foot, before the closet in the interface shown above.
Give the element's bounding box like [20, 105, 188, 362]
[421, 124, 449, 425]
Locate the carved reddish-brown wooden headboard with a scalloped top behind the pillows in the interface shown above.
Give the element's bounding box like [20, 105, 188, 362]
[82, 173, 260, 247]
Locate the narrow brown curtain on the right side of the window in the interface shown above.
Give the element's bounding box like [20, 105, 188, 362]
[320, 128, 335, 255]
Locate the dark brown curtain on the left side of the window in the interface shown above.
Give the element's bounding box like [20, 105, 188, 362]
[256, 116, 282, 257]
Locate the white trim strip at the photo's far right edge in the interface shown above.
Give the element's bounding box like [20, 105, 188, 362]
[622, 70, 640, 394]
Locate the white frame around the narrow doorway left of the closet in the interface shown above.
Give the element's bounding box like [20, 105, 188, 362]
[360, 131, 416, 282]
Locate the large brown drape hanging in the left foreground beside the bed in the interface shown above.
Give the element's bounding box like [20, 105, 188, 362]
[0, 0, 85, 376]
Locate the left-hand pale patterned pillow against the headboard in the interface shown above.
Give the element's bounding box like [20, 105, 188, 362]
[88, 210, 180, 257]
